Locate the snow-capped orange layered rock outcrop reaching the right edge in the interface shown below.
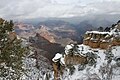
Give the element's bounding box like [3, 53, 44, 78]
[83, 23, 120, 49]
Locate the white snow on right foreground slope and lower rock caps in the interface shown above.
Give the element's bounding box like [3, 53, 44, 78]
[52, 44, 120, 80]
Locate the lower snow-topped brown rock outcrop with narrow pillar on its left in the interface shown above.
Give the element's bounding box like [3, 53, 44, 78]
[52, 44, 94, 80]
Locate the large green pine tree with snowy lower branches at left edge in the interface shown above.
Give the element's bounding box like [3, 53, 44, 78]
[0, 18, 28, 80]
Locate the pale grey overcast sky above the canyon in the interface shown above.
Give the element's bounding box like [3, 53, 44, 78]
[0, 0, 120, 19]
